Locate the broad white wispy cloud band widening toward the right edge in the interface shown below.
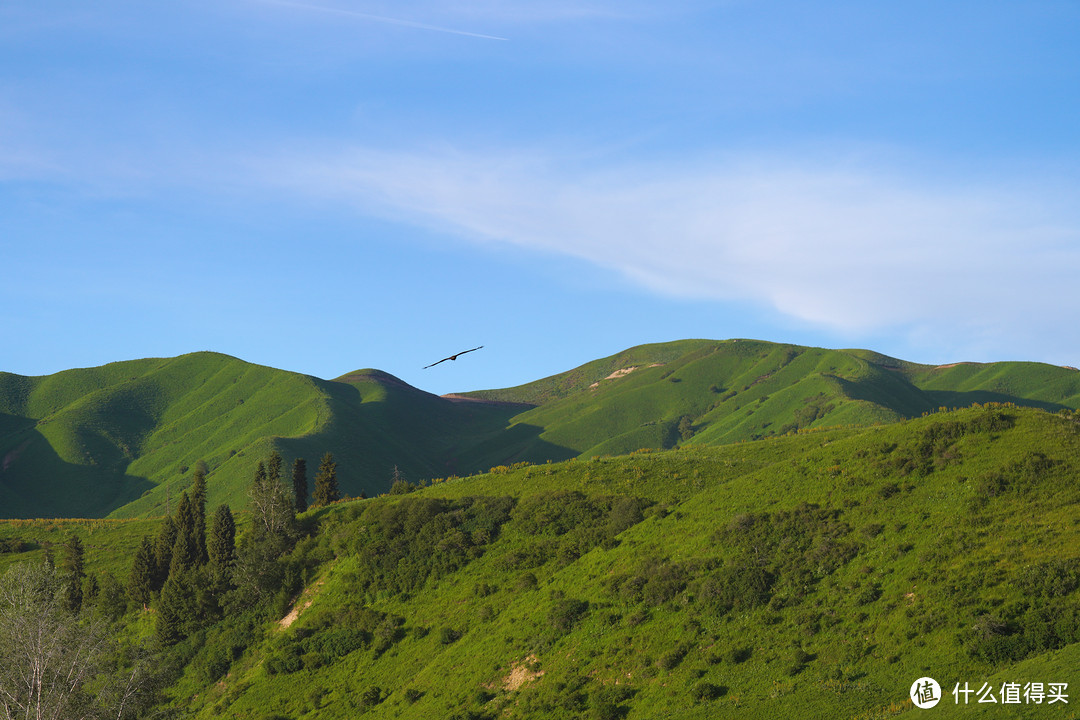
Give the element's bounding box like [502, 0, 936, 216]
[259, 148, 1080, 360]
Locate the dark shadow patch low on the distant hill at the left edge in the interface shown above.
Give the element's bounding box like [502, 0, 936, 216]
[0, 429, 154, 518]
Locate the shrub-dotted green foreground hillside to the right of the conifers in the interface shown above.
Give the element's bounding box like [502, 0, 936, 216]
[71, 406, 1080, 720]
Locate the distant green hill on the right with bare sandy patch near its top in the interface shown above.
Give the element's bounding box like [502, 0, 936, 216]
[471, 340, 1080, 461]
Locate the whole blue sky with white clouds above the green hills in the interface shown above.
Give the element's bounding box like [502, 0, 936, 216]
[0, 0, 1080, 393]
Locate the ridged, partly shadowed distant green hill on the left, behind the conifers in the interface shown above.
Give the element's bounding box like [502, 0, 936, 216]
[0, 353, 524, 517]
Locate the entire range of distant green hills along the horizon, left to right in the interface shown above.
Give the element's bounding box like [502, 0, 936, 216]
[0, 340, 1080, 517]
